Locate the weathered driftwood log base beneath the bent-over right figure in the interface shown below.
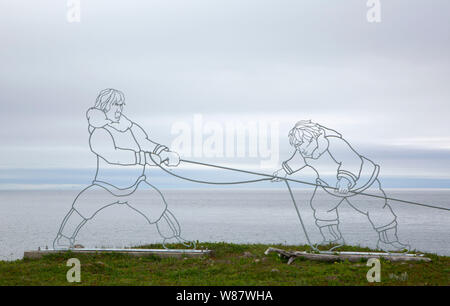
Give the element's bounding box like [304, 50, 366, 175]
[264, 248, 431, 265]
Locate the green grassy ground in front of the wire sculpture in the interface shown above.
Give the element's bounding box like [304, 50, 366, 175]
[0, 243, 450, 286]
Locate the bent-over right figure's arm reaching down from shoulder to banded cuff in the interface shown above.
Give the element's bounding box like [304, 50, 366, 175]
[328, 137, 363, 189]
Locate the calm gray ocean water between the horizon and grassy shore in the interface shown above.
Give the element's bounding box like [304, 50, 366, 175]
[0, 189, 450, 260]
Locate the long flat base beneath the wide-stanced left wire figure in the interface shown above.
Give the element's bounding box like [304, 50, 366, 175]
[23, 248, 212, 259]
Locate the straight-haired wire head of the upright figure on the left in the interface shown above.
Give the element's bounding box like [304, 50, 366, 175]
[95, 88, 125, 122]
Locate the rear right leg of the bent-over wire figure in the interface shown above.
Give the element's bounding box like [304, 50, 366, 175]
[348, 180, 409, 251]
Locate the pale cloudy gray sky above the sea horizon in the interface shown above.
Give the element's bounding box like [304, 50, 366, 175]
[0, 0, 450, 187]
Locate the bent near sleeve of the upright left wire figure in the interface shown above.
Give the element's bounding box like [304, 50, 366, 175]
[89, 128, 140, 166]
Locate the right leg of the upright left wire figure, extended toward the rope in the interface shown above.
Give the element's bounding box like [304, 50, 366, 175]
[127, 182, 194, 247]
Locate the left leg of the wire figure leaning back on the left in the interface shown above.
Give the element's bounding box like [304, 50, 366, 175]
[53, 185, 117, 249]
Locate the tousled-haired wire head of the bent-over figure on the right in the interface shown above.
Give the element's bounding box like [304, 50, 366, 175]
[289, 120, 328, 159]
